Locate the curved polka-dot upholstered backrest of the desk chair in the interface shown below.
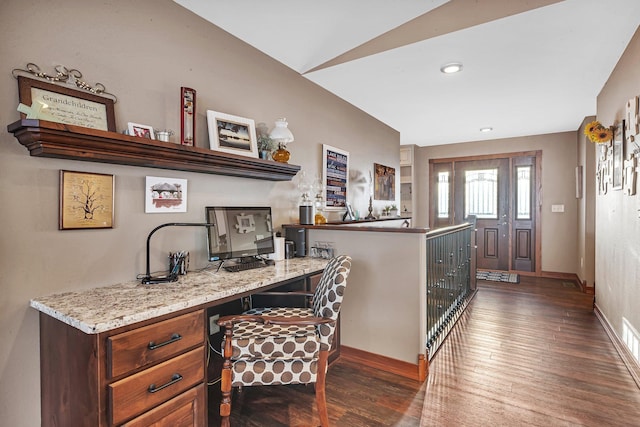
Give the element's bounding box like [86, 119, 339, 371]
[313, 255, 351, 350]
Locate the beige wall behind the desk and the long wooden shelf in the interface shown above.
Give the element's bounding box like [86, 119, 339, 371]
[0, 0, 399, 426]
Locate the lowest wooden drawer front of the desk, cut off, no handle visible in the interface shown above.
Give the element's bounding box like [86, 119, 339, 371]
[122, 384, 206, 427]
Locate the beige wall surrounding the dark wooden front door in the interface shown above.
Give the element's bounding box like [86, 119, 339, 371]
[415, 132, 578, 273]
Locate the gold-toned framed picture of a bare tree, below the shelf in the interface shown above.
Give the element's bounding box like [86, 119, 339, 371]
[59, 170, 115, 230]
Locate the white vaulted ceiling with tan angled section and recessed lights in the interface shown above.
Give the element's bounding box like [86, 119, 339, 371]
[174, 0, 640, 146]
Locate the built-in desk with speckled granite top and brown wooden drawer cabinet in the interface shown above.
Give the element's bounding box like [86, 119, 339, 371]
[31, 258, 327, 426]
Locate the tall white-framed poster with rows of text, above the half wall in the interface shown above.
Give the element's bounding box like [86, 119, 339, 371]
[322, 144, 349, 210]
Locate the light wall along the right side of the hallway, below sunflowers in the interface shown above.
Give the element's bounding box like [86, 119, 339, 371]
[594, 26, 640, 342]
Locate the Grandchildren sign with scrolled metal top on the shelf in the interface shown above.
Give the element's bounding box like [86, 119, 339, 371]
[12, 63, 116, 132]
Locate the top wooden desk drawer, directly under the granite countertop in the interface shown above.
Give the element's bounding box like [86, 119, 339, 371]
[107, 310, 204, 378]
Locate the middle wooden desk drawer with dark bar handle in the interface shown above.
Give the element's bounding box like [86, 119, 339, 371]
[108, 347, 204, 425]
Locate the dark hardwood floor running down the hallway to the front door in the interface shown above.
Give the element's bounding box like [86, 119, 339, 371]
[209, 277, 640, 427]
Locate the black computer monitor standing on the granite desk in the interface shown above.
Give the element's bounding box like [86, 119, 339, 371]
[205, 206, 275, 261]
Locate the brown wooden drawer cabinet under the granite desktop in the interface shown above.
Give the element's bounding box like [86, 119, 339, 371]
[40, 310, 207, 427]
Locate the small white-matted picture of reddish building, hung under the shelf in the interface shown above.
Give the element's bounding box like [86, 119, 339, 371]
[144, 176, 187, 213]
